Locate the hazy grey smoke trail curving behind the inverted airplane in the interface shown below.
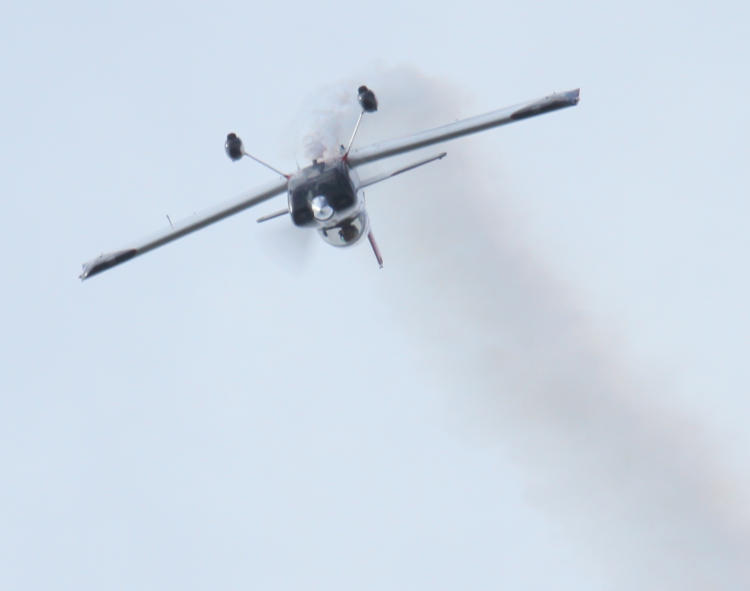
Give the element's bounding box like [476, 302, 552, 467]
[315, 68, 750, 590]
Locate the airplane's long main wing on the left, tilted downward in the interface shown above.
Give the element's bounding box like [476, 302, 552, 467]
[80, 179, 288, 279]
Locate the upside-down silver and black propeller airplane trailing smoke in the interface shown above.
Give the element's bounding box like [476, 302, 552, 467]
[79, 86, 580, 280]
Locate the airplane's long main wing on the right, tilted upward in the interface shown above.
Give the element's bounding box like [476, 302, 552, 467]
[348, 88, 580, 166]
